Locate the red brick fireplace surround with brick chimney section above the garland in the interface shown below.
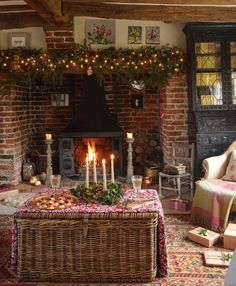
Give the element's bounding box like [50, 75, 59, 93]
[0, 27, 193, 184]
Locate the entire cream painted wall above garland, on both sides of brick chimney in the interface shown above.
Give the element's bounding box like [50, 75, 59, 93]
[0, 17, 186, 50]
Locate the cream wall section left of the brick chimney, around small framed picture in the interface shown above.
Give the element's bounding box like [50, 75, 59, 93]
[0, 27, 46, 50]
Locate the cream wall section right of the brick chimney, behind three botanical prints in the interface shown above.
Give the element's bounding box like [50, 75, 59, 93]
[74, 17, 186, 50]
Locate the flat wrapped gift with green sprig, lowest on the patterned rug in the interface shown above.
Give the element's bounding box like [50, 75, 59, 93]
[204, 250, 233, 267]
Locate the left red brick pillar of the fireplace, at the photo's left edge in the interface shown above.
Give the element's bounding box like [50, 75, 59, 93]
[0, 85, 31, 184]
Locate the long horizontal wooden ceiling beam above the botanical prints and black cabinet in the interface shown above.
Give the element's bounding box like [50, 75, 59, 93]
[63, 2, 236, 22]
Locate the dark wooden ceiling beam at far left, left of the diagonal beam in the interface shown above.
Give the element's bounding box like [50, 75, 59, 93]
[0, 12, 45, 30]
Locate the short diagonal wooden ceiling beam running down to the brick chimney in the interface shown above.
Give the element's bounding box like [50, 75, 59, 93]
[25, 0, 70, 25]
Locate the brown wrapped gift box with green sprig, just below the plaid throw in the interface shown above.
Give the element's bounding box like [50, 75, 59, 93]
[188, 227, 220, 247]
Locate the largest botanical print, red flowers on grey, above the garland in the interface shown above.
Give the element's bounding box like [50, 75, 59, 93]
[85, 19, 115, 45]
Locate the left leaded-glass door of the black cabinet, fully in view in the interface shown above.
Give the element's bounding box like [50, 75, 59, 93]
[194, 41, 224, 109]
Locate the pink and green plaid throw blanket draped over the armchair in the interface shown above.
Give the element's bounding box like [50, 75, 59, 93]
[190, 179, 236, 232]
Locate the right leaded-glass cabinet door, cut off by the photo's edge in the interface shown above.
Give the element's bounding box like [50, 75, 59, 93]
[229, 41, 236, 106]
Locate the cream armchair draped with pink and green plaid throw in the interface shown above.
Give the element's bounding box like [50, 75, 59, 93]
[191, 140, 236, 232]
